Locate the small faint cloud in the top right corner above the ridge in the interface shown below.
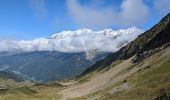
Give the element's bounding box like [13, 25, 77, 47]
[154, 0, 170, 15]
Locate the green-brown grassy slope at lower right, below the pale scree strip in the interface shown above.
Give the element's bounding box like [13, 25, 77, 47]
[73, 48, 170, 100]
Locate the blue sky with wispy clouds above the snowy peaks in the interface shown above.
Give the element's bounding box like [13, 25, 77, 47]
[0, 0, 170, 39]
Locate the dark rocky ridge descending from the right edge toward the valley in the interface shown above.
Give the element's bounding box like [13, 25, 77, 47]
[78, 13, 170, 77]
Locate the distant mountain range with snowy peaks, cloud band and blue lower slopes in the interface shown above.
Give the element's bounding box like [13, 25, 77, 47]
[0, 27, 143, 82]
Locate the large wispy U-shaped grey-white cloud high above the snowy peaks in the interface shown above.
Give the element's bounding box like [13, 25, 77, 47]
[67, 0, 149, 28]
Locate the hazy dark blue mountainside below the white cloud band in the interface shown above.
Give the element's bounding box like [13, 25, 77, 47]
[0, 51, 108, 82]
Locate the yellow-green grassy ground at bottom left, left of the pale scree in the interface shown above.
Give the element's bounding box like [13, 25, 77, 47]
[0, 79, 61, 100]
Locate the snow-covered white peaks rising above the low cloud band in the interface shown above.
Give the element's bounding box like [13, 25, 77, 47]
[51, 27, 143, 39]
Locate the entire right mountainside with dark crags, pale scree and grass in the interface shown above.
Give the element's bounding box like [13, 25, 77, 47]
[58, 14, 170, 100]
